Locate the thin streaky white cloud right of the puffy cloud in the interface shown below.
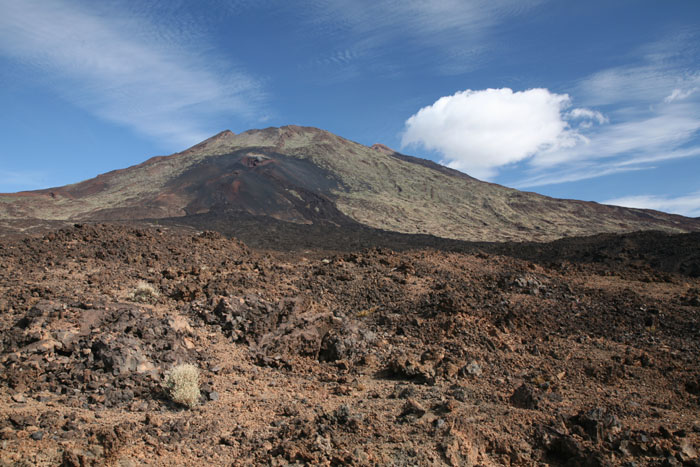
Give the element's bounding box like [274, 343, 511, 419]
[512, 36, 700, 188]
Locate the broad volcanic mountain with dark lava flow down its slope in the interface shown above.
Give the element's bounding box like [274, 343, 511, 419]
[0, 126, 700, 241]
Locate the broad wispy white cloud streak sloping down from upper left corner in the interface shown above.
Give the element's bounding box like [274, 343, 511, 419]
[0, 0, 264, 147]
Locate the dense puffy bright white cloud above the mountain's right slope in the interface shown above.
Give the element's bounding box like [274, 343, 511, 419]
[401, 88, 604, 179]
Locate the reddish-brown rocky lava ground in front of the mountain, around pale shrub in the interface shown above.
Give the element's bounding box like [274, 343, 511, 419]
[0, 225, 700, 466]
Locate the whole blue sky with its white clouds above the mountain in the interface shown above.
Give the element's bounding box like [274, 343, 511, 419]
[0, 0, 700, 217]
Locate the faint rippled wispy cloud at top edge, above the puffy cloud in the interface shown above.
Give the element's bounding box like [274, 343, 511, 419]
[305, 0, 545, 74]
